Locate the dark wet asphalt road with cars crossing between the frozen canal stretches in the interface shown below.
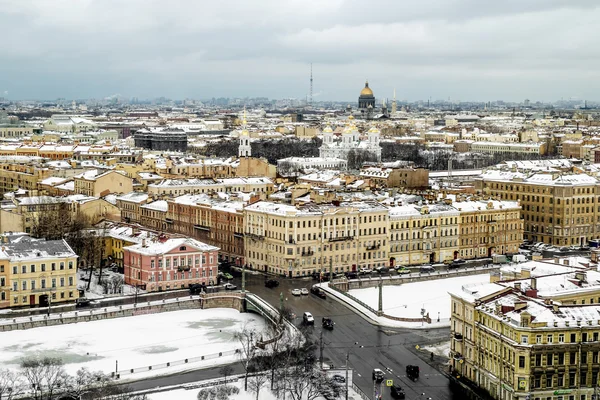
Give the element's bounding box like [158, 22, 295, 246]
[128, 271, 467, 400]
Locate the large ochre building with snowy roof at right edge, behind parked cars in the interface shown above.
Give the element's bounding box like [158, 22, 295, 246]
[475, 169, 600, 246]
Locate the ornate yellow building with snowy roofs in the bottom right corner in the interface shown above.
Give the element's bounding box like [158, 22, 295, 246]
[450, 263, 600, 400]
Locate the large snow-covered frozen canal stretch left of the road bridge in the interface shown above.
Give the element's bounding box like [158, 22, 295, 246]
[0, 308, 266, 378]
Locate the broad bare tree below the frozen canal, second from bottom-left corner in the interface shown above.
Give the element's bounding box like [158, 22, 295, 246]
[21, 357, 68, 400]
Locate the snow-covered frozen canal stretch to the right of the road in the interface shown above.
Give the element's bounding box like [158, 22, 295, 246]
[336, 274, 490, 327]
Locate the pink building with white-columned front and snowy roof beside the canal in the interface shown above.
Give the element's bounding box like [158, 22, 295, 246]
[123, 237, 219, 292]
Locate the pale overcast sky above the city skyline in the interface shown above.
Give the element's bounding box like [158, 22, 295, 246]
[0, 0, 600, 101]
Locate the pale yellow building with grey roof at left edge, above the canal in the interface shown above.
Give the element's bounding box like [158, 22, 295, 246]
[0, 235, 79, 308]
